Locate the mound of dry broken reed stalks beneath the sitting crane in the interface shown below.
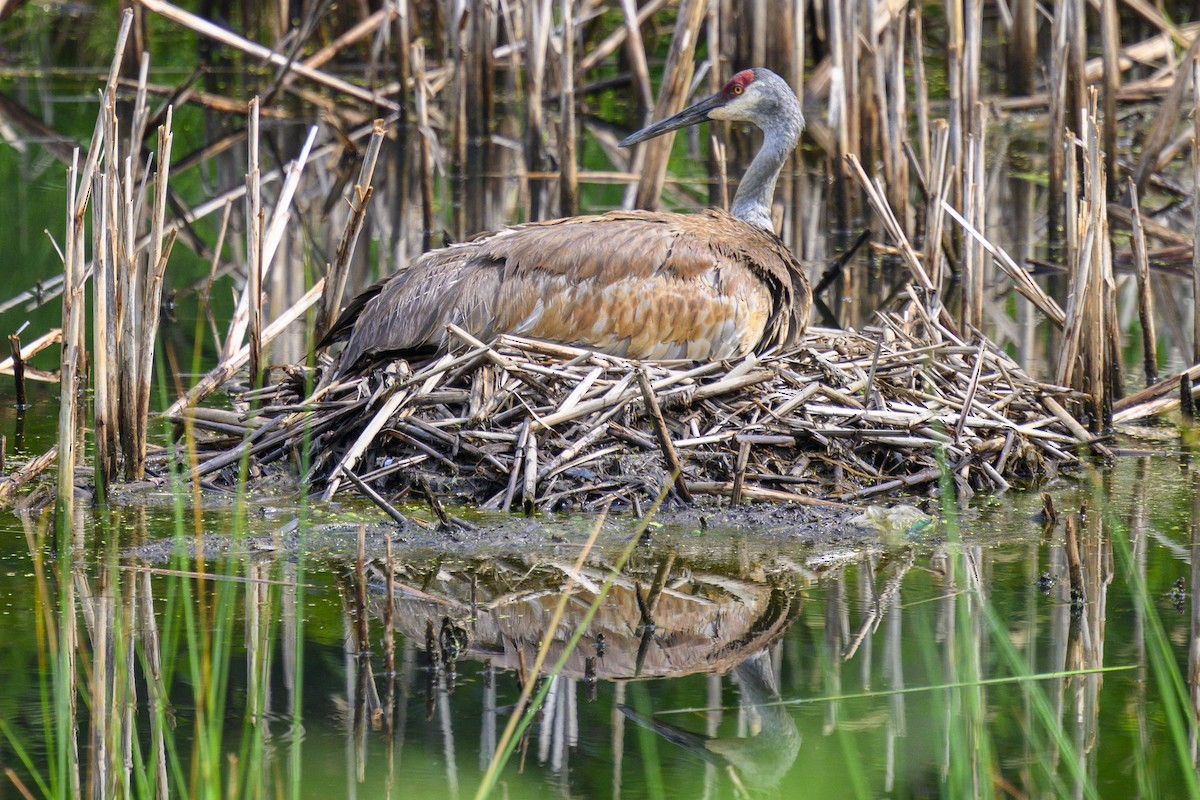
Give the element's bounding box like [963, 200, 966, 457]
[174, 309, 1090, 511]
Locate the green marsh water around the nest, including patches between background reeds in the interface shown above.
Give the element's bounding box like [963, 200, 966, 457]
[7, 6, 1200, 799]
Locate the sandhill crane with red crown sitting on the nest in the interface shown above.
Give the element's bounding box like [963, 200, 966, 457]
[320, 68, 812, 373]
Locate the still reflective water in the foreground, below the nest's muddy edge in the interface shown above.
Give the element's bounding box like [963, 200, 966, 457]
[7, 458, 1200, 798]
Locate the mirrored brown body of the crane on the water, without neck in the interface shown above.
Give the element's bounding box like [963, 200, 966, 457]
[372, 554, 800, 680]
